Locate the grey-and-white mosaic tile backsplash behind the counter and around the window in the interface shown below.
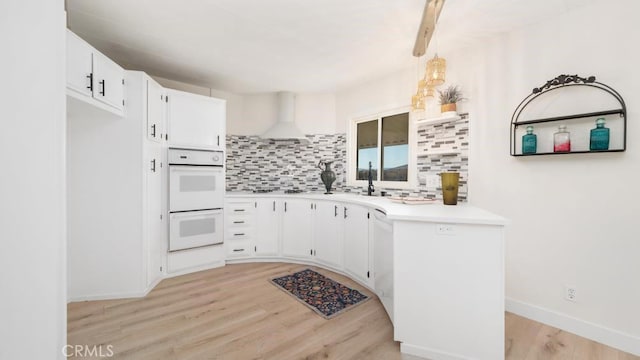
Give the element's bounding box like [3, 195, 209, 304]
[226, 115, 469, 201]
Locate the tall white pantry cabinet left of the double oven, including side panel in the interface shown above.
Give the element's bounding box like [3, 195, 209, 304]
[67, 71, 167, 301]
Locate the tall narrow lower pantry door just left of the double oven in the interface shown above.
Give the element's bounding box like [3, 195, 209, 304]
[145, 144, 167, 286]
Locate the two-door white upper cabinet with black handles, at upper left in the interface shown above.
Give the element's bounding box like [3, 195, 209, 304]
[67, 30, 124, 115]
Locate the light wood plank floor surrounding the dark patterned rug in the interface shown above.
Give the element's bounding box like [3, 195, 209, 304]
[68, 263, 640, 360]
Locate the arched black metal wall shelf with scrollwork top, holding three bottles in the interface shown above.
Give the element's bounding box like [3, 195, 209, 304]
[510, 75, 627, 156]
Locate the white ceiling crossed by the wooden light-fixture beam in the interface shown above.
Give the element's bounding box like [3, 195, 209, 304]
[67, 0, 595, 93]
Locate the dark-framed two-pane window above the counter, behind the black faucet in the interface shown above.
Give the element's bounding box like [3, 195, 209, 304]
[352, 112, 409, 185]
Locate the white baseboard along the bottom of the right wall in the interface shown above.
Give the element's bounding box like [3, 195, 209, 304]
[505, 298, 640, 356]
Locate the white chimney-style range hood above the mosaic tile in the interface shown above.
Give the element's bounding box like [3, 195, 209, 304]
[261, 91, 309, 144]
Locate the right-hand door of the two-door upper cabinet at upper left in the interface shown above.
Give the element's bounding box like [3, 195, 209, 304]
[93, 51, 124, 110]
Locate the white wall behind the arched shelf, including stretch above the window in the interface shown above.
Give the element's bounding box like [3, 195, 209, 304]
[336, 0, 640, 355]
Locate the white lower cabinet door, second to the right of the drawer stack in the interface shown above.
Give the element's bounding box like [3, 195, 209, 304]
[282, 199, 313, 259]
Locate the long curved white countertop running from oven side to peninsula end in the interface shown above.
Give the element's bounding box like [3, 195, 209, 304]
[226, 192, 509, 225]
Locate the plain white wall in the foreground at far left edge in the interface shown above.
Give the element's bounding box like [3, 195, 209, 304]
[0, 0, 67, 359]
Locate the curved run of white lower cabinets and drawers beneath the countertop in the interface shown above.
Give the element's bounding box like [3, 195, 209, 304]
[225, 197, 374, 288]
